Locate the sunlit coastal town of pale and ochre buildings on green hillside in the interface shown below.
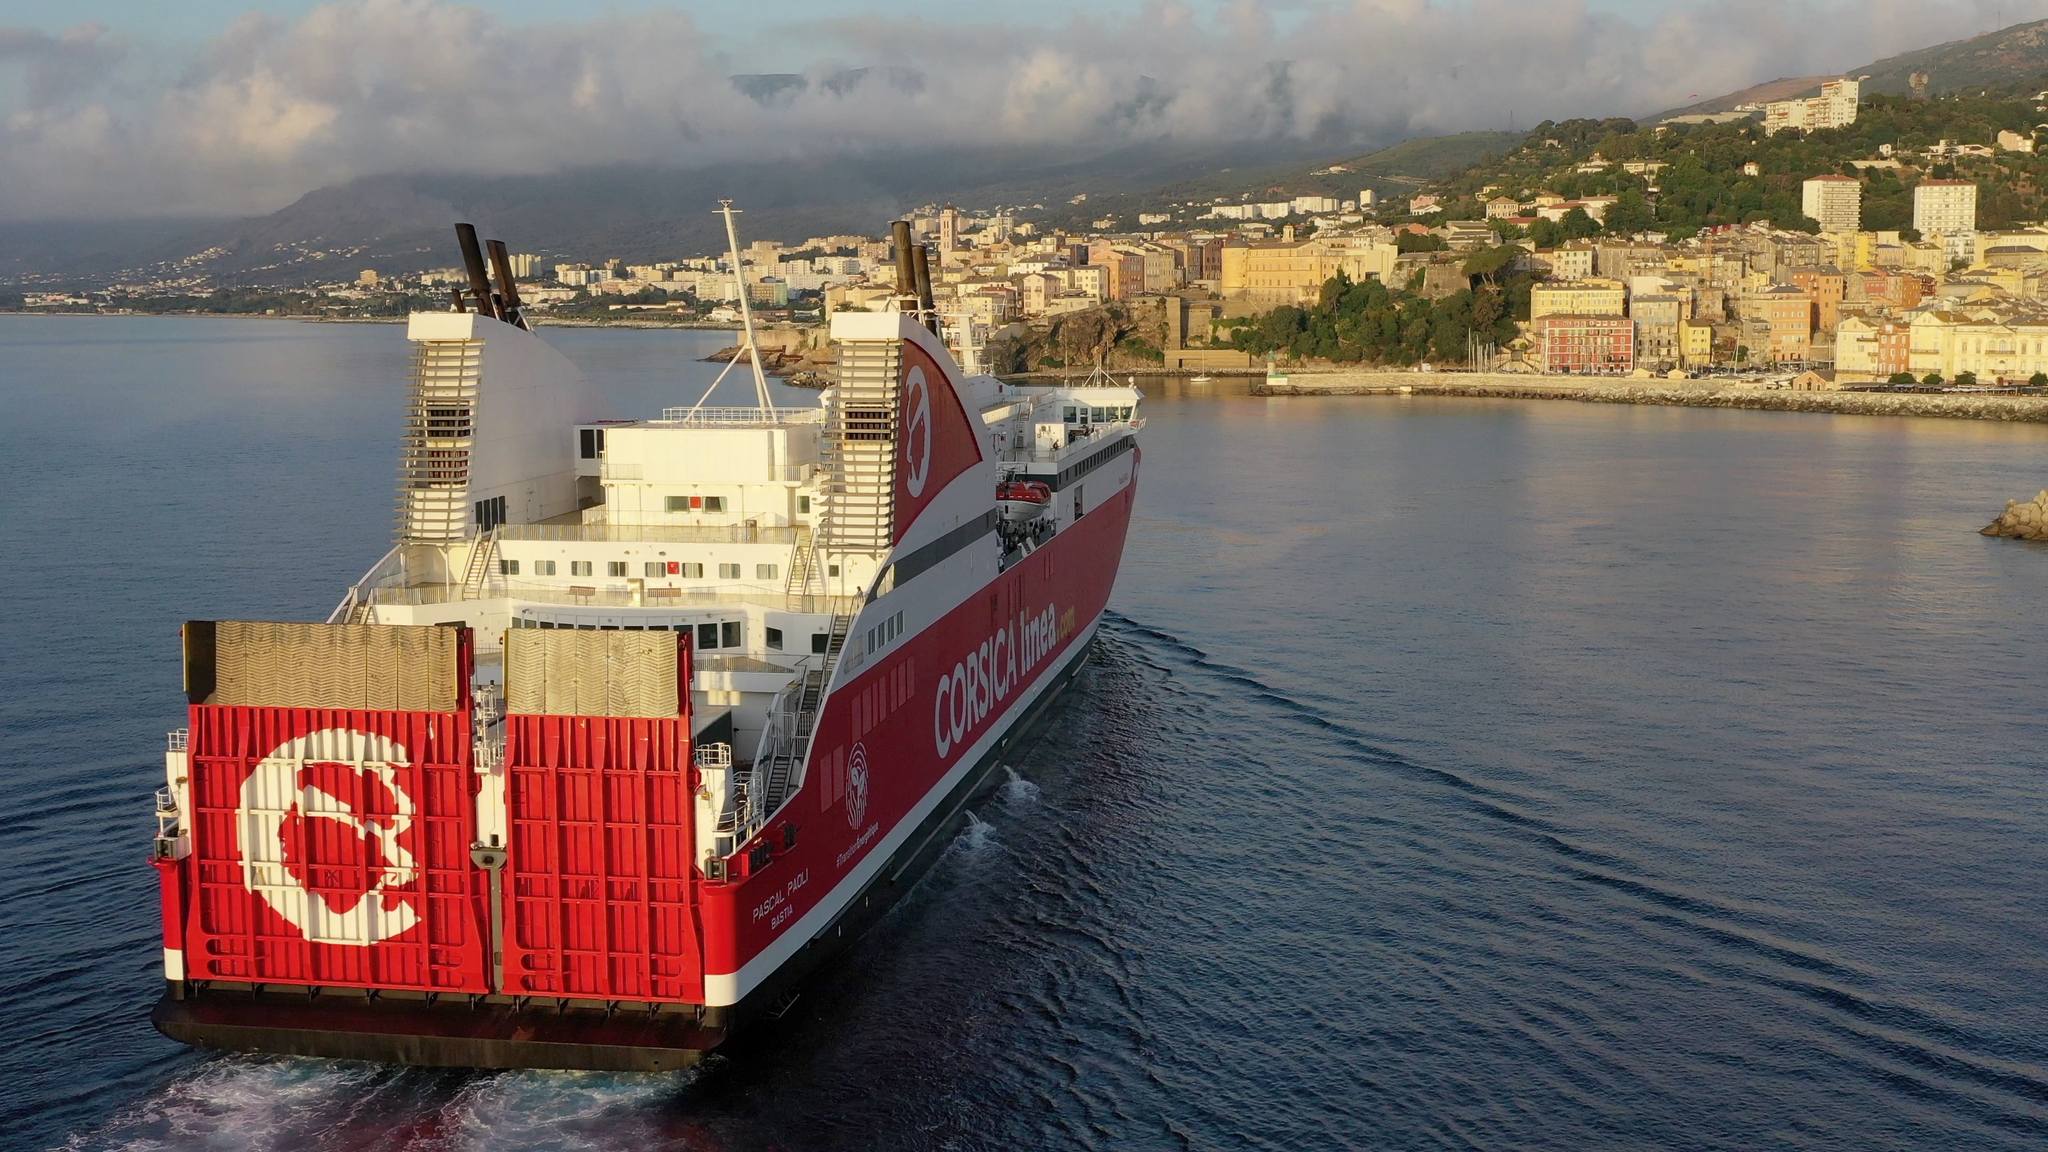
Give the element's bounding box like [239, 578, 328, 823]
[18, 78, 2048, 389]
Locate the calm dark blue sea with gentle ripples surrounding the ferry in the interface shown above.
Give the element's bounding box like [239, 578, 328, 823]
[0, 309, 2048, 1152]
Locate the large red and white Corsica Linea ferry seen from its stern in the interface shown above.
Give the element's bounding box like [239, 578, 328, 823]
[154, 217, 1143, 1068]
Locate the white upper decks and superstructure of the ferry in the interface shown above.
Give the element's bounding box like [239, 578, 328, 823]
[332, 312, 1139, 754]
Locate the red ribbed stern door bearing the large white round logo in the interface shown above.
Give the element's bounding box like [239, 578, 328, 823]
[178, 705, 489, 992]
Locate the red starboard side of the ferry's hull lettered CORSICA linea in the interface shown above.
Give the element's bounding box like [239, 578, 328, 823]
[702, 457, 1137, 1004]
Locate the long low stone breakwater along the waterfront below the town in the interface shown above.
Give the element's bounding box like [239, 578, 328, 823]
[1251, 371, 2048, 424]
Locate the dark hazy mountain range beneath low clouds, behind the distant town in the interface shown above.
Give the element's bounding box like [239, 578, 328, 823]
[0, 133, 1358, 283]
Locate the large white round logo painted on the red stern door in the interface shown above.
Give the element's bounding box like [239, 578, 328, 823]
[236, 728, 420, 947]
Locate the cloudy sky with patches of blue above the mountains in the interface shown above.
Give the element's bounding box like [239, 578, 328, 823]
[0, 0, 2048, 219]
